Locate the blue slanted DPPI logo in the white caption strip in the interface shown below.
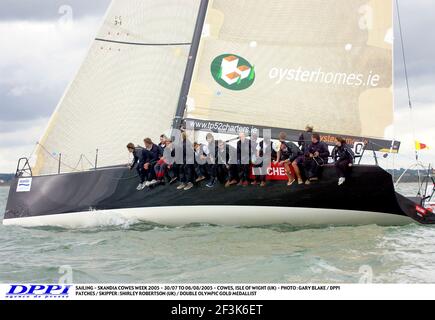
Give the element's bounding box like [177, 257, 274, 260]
[6, 285, 71, 298]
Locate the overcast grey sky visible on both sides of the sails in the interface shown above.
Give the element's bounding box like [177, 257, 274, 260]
[0, 0, 435, 172]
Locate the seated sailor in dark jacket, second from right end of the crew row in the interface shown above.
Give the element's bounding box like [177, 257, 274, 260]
[304, 133, 329, 184]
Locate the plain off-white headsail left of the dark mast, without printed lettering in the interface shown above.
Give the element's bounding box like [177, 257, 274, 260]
[34, 0, 200, 174]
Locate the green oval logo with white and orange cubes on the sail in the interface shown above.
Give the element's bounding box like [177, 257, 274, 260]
[211, 54, 255, 91]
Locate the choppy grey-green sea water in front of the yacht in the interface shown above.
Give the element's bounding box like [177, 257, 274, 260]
[0, 184, 435, 283]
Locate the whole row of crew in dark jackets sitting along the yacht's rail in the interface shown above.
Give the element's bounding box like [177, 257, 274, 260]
[127, 126, 355, 191]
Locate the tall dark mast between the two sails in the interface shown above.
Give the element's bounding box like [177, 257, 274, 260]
[172, 0, 209, 130]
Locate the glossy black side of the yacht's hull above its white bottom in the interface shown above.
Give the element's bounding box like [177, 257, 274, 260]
[4, 166, 435, 224]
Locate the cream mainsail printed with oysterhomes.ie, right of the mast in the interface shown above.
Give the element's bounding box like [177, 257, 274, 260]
[186, 0, 393, 139]
